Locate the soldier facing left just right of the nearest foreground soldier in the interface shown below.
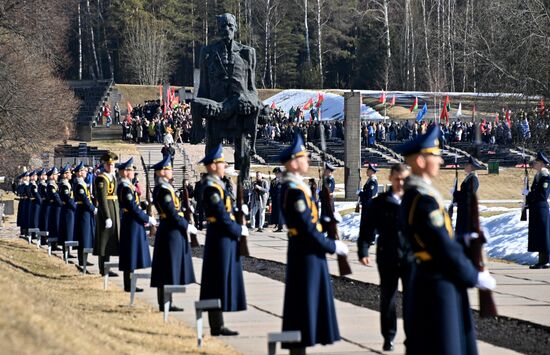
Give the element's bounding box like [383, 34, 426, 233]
[453, 156, 483, 235]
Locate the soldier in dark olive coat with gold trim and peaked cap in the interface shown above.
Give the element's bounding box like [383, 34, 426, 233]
[94, 152, 120, 276]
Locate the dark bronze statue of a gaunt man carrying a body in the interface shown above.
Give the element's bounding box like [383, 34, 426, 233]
[191, 13, 263, 181]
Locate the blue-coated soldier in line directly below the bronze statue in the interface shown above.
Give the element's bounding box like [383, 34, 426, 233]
[200, 144, 248, 336]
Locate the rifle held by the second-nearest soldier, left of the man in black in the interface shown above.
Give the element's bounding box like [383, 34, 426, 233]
[320, 124, 351, 276]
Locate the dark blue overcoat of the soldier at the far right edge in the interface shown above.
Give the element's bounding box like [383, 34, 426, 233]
[526, 169, 550, 253]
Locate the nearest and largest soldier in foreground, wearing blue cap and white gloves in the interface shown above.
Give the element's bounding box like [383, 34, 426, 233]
[398, 125, 496, 355]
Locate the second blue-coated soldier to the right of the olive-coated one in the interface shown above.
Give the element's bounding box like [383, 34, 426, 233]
[151, 154, 197, 312]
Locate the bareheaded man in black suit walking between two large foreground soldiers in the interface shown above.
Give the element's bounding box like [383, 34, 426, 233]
[357, 163, 411, 351]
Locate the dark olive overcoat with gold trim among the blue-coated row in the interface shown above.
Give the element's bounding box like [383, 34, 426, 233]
[94, 173, 120, 256]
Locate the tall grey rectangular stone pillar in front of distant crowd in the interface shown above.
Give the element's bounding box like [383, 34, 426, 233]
[344, 91, 361, 200]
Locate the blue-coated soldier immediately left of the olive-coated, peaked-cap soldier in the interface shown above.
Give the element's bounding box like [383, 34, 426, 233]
[73, 162, 97, 266]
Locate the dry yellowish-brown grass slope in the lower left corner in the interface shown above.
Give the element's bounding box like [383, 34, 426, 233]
[0, 233, 236, 354]
